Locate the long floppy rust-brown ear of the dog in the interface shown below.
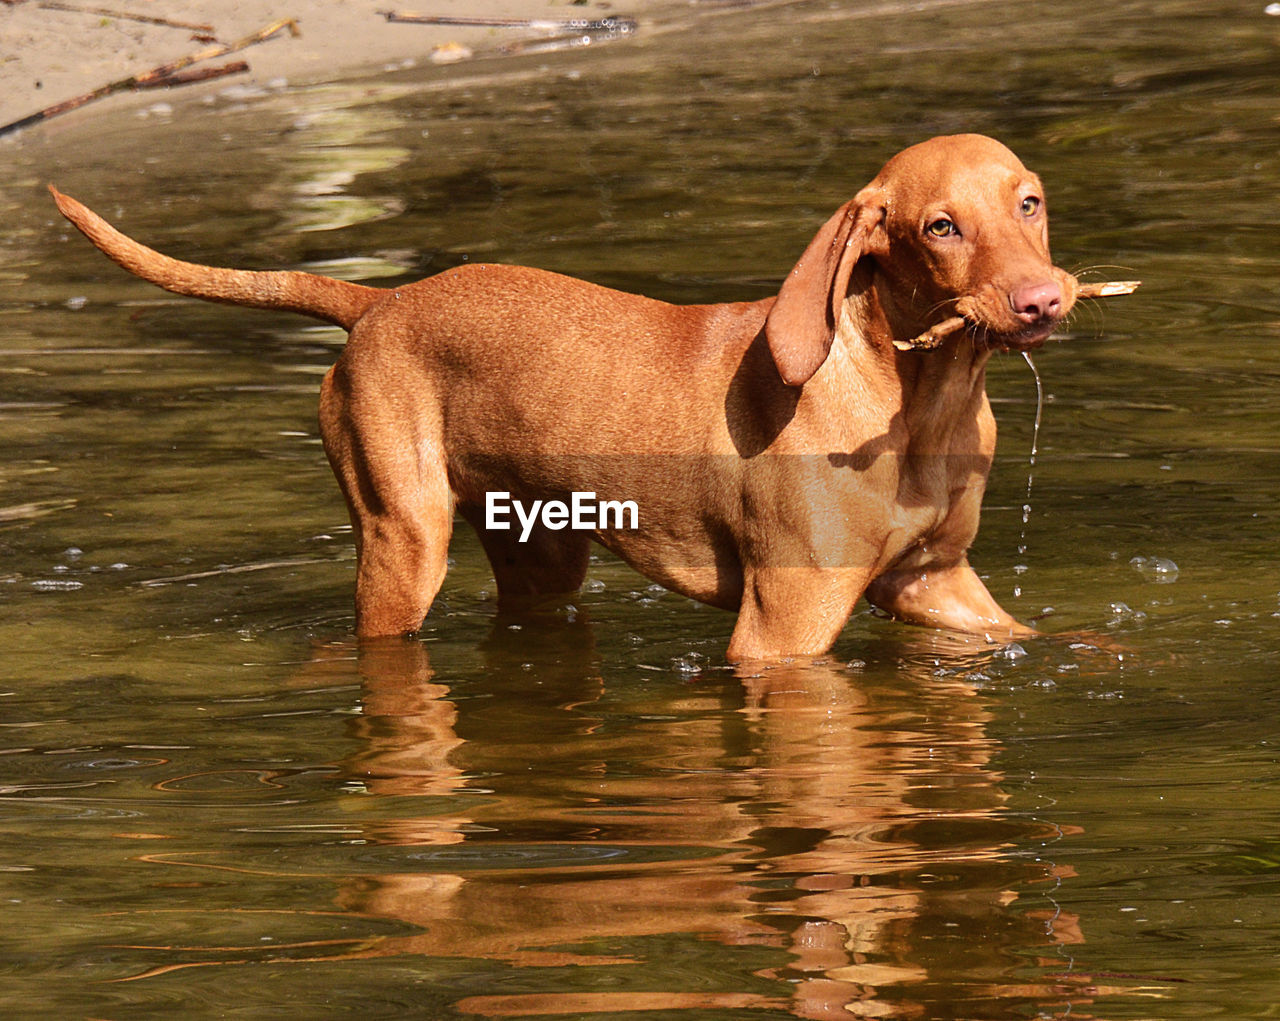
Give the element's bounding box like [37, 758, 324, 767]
[764, 194, 882, 386]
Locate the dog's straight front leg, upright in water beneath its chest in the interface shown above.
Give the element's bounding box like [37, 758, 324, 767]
[728, 567, 868, 663]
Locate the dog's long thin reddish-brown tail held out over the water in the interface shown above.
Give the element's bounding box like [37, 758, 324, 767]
[49, 184, 387, 330]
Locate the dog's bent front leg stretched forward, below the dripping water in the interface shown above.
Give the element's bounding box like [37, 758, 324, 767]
[867, 560, 1037, 641]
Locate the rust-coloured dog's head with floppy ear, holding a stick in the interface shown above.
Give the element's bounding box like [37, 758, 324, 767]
[765, 134, 1076, 385]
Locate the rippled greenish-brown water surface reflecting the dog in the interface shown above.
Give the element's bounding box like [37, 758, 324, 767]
[0, 0, 1280, 1021]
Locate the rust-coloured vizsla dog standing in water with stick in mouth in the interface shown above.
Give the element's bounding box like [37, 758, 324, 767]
[51, 134, 1076, 660]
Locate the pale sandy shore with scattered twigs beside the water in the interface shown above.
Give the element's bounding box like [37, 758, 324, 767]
[0, 0, 696, 133]
